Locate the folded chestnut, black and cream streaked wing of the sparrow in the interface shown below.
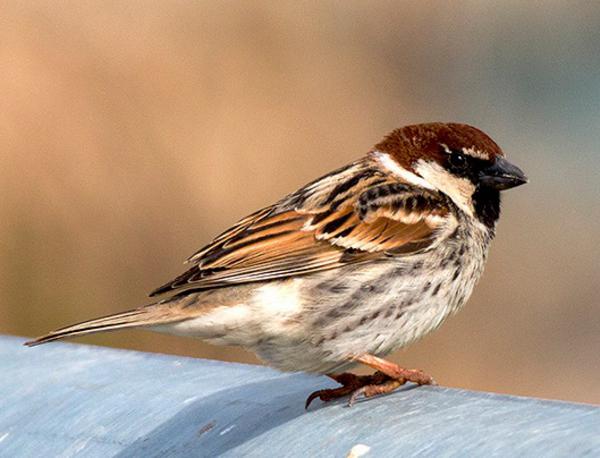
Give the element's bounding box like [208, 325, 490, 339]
[151, 161, 451, 295]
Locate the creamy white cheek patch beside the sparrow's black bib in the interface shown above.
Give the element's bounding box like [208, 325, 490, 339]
[415, 160, 475, 216]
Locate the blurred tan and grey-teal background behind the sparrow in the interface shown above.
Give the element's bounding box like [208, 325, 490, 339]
[0, 0, 600, 403]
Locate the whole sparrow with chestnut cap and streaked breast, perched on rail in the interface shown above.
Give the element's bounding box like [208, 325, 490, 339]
[26, 122, 528, 408]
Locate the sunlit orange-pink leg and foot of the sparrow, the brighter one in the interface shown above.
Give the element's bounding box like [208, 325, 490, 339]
[349, 354, 436, 405]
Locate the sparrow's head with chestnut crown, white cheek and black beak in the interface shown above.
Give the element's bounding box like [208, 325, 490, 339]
[372, 123, 527, 225]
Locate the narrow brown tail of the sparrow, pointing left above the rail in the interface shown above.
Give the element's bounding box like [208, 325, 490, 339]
[25, 303, 182, 347]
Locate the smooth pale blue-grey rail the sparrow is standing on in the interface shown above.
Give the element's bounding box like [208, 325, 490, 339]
[0, 336, 600, 457]
